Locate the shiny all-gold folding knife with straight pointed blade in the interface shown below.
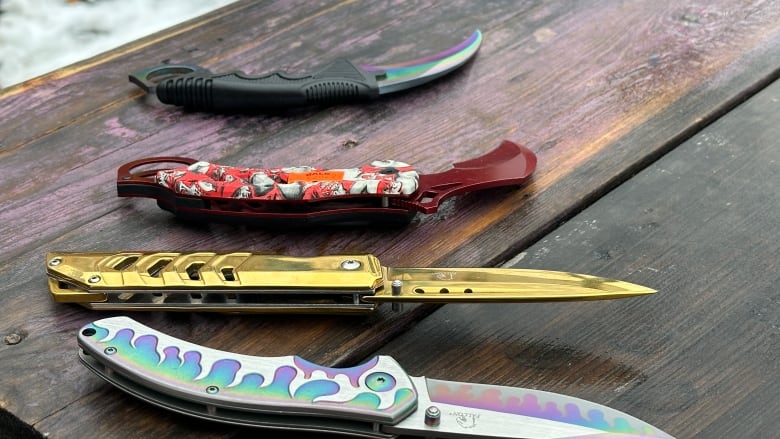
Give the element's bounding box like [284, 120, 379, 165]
[46, 252, 655, 313]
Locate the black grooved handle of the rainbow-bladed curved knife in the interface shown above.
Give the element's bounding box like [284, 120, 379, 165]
[156, 59, 383, 112]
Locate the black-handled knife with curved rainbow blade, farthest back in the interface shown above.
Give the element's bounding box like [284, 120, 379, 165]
[130, 30, 482, 112]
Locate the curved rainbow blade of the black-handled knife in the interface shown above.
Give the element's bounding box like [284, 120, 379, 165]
[360, 30, 482, 94]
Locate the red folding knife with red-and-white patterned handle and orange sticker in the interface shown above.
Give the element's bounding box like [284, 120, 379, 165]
[117, 140, 536, 227]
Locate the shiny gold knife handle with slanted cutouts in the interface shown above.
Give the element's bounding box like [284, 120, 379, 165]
[46, 252, 383, 312]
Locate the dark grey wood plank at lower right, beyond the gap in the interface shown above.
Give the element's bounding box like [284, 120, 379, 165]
[379, 79, 780, 438]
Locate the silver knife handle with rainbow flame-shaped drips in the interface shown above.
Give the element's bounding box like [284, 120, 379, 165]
[78, 317, 417, 437]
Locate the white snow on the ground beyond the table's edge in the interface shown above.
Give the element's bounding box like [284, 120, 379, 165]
[0, 0, 235, 87]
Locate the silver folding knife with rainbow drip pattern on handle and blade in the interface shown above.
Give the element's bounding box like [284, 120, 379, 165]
[78, 317, 673, 439]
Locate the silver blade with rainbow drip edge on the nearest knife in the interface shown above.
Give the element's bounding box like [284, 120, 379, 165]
[384, 377, 673, 439]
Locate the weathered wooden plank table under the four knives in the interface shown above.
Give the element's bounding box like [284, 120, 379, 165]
[0, 0, 780, 439]
